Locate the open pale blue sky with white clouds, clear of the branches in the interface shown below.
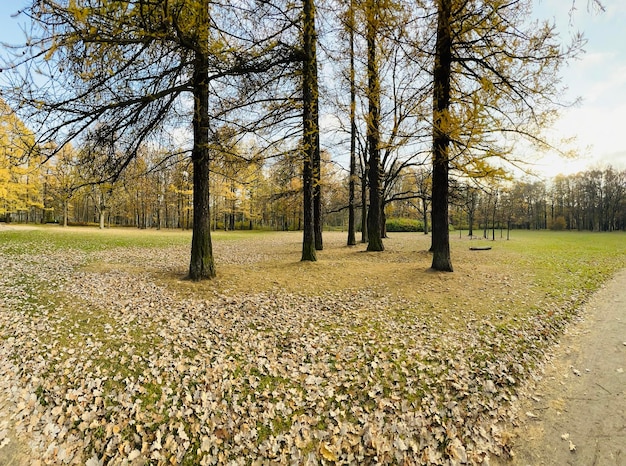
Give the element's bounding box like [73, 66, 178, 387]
[0, 0, 626, 178]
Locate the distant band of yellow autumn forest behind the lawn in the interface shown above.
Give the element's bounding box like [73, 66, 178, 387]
[0, 113, 626, 236]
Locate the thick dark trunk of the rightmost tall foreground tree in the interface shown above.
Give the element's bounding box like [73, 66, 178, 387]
[431, 0, 453, 272]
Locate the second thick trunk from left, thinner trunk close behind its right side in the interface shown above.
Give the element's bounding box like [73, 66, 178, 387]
[301, 0, 314, 261]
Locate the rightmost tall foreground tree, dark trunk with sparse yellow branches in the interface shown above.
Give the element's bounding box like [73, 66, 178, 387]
[431, 0, 582, 271]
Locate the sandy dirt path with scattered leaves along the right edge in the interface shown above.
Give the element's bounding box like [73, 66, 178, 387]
[504, 270, 626, 466]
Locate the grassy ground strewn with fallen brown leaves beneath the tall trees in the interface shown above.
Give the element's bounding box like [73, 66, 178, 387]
[0, 229, 623, 466]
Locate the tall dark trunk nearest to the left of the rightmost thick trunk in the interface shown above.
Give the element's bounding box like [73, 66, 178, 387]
[366, 0, 385, 251]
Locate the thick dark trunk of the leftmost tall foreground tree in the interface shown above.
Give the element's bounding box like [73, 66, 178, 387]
[189, 11, 215, 280]
